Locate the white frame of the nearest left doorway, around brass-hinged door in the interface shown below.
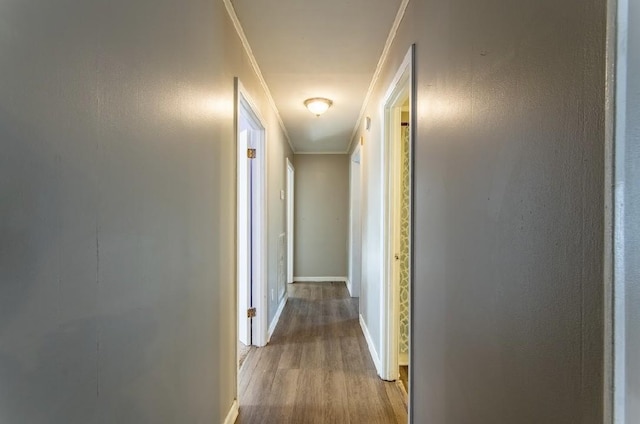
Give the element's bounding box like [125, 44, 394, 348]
[234, 77, 267, 346]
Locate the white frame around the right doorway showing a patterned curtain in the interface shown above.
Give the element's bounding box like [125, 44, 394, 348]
[380, 45, 416, 386]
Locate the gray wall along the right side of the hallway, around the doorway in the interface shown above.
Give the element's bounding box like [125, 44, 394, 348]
[355, 0, 606, 424]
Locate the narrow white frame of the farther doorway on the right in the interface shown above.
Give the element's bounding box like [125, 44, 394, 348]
[347, 143, 362, 297]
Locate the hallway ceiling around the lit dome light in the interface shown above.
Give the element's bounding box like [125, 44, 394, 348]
[232, 0, 401, 153]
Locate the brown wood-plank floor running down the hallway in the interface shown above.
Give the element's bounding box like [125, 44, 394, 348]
[236, 283, 407, 424]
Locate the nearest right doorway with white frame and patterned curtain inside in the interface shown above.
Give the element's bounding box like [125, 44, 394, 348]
[381, 46, 415, 416]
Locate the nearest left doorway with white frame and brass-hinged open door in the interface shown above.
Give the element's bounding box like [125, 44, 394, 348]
[236, 79, 266, 374]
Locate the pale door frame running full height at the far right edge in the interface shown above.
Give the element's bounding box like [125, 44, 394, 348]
[604, 0, 640, 424]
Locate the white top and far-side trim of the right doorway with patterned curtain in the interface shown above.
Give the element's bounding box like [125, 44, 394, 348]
[380, 45, 415, 380]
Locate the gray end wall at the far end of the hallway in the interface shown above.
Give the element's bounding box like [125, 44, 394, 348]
[293, 155, 349, 277]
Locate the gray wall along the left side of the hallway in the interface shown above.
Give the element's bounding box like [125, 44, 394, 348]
[0, 0, 290, 424]
